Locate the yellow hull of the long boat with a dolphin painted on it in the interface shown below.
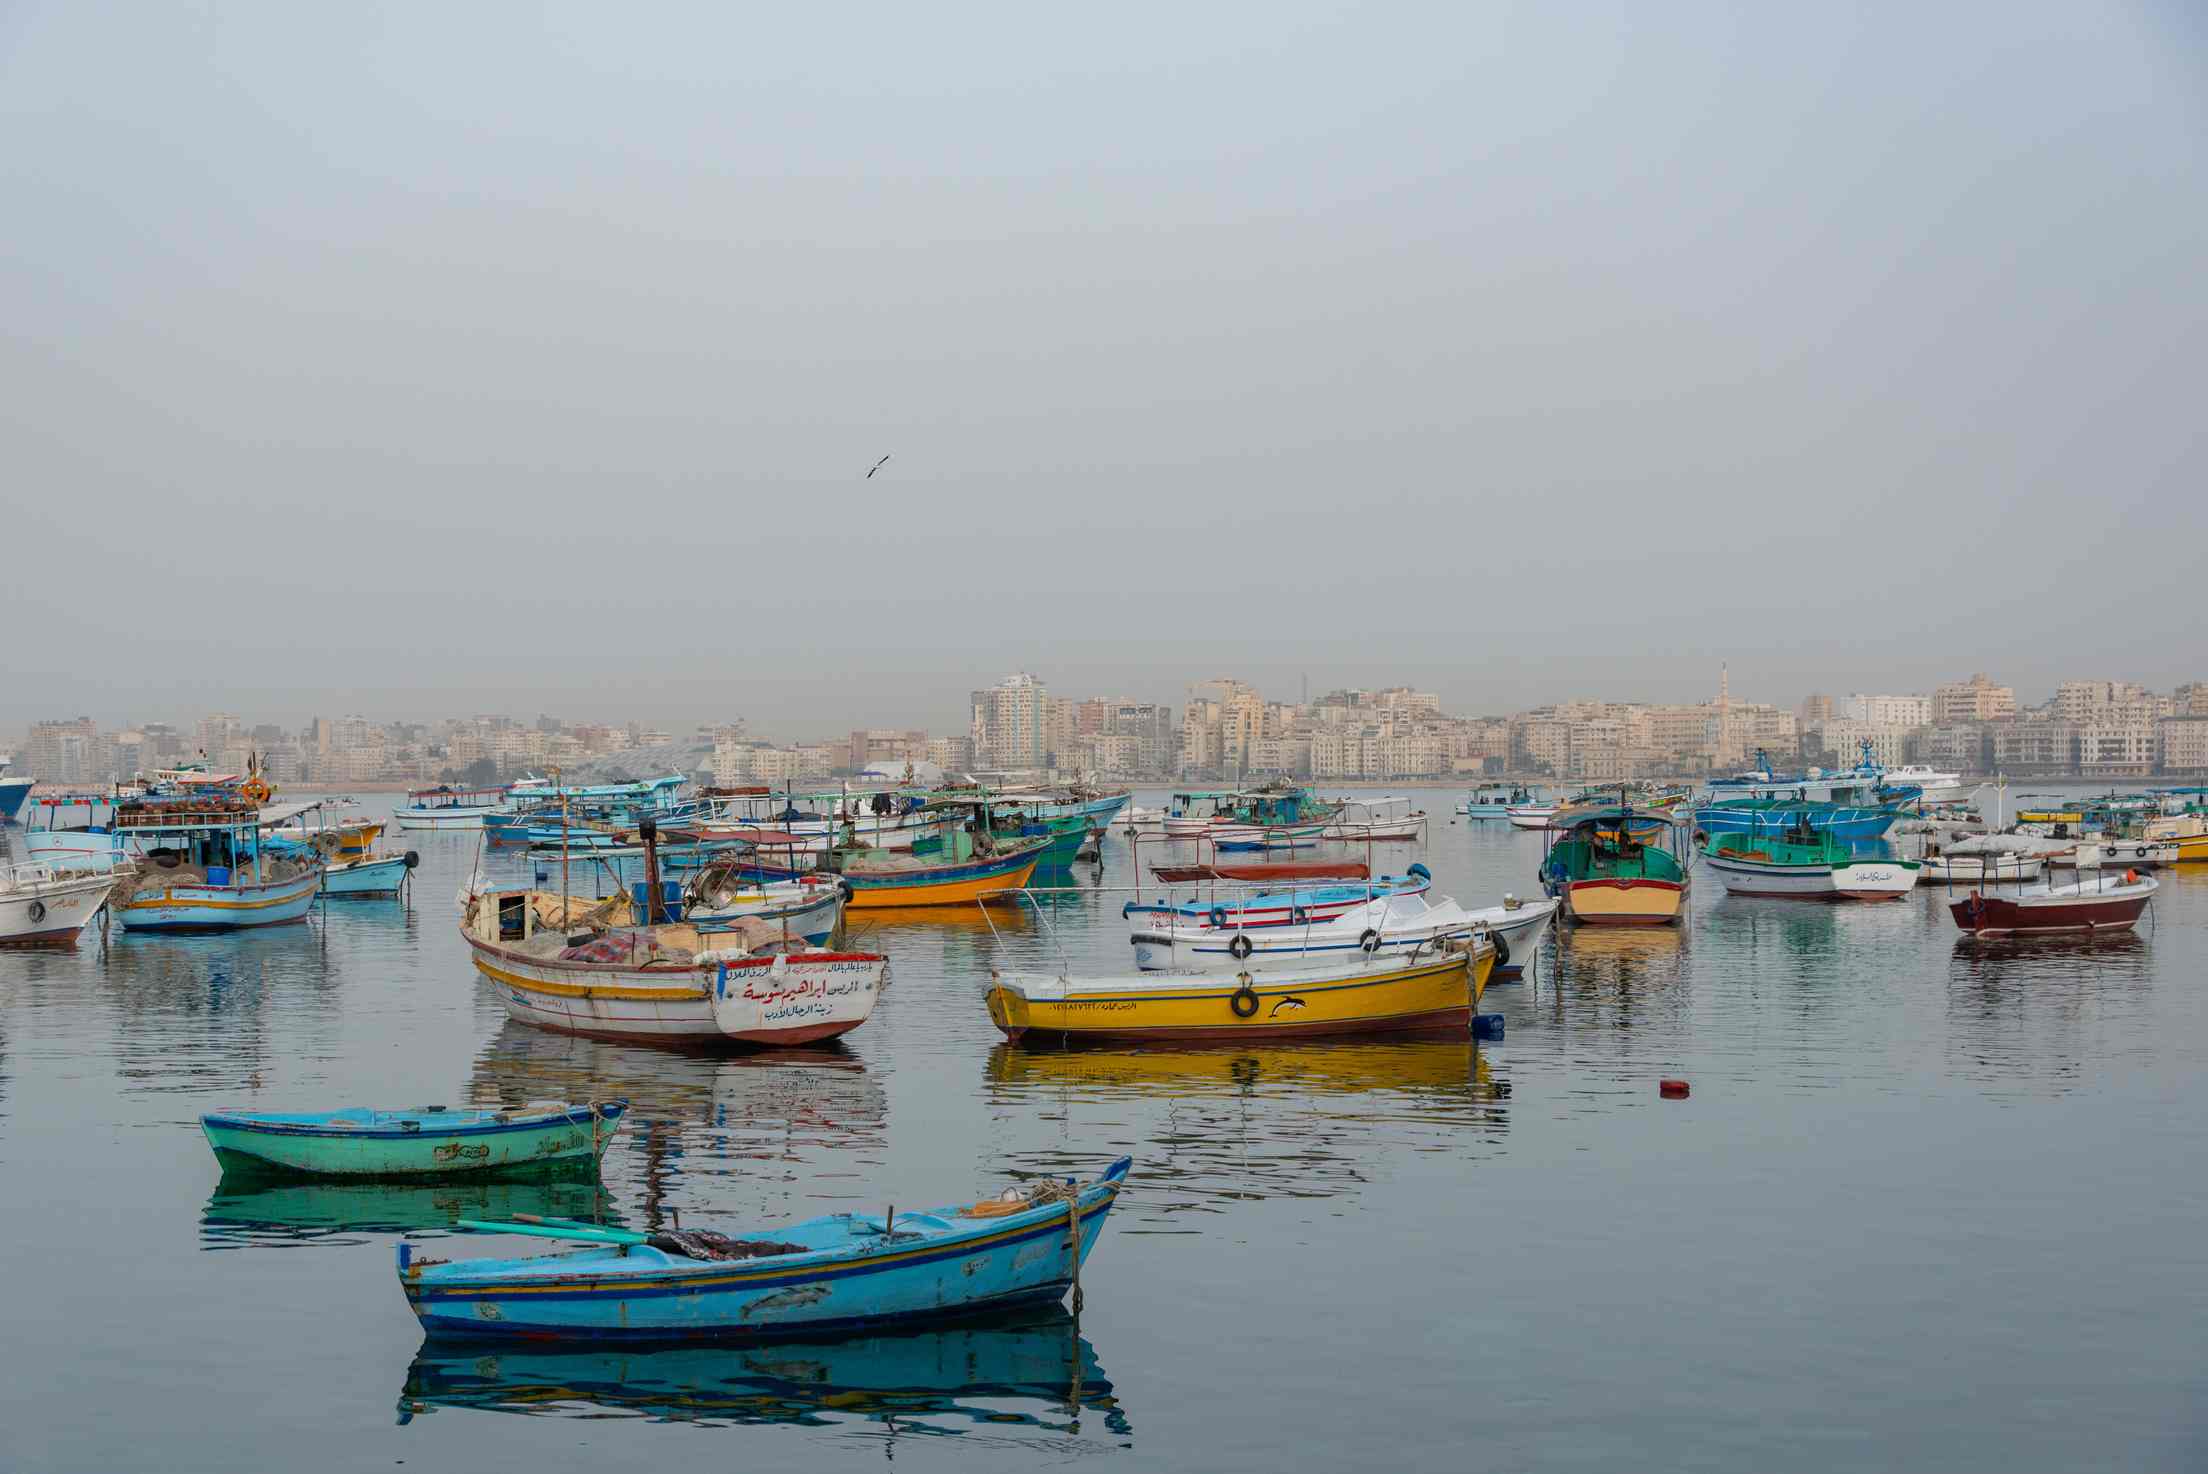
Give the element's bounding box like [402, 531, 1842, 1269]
[989, 951, 1495, 1039]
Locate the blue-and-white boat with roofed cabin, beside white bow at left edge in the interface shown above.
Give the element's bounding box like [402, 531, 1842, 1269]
[108, 792, 322, 931]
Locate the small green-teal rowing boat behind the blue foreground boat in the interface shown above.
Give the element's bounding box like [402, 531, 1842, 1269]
[199, 1101, 629, 1176]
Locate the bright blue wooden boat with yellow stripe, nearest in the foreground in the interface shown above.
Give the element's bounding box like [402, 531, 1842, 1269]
[397, 1156, 1133, 1342]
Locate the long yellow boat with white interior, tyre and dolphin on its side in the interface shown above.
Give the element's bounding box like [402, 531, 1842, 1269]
[989, 936, 1495, 1044]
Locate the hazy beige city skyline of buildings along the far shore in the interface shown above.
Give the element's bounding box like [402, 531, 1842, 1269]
[18, 666, 2208, 786]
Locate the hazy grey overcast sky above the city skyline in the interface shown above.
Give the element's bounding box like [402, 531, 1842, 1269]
[0, 0, 2208, 737]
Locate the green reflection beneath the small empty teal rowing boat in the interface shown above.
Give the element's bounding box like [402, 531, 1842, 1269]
[199, 1167, 623, 1249]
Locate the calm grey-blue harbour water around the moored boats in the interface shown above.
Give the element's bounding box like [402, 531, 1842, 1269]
[0, 790, 2208, 1474]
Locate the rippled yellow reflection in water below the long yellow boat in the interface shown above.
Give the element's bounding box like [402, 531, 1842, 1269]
[987, 1035, 1510, 1222]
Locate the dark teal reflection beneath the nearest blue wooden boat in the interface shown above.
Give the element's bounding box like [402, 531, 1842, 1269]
[397, 1306, 1133, 1439]
